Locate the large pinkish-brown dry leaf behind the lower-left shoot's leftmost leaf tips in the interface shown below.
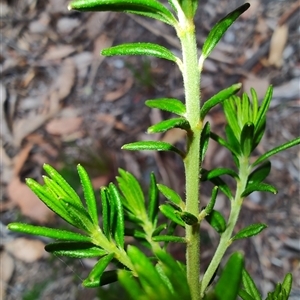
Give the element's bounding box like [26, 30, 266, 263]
[7, 177, 54, 224]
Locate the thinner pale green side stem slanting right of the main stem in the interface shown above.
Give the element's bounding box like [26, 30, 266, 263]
[201, 157, 251, 297]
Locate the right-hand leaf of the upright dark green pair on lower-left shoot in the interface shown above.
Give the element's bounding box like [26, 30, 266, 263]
[109, 183, 124, 249]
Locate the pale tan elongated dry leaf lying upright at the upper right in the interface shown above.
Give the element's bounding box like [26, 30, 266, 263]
[268, 24, 289, 68]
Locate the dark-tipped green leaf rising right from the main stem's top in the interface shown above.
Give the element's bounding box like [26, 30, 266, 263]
[202, 3, 250, 58]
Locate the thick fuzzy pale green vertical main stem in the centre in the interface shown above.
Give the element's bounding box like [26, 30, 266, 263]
[178, 21, 202, 300]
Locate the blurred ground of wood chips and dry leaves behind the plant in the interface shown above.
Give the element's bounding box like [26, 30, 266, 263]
[0, 0, 300, 300]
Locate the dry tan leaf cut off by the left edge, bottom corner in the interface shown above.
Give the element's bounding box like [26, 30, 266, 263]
[0, 251, 15, 300]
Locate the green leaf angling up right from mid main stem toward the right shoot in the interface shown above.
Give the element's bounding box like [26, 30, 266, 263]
[200, 83, 242, 120]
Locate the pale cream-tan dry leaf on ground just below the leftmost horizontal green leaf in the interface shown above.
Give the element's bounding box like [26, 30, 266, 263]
[5, 238, 48, 263]
